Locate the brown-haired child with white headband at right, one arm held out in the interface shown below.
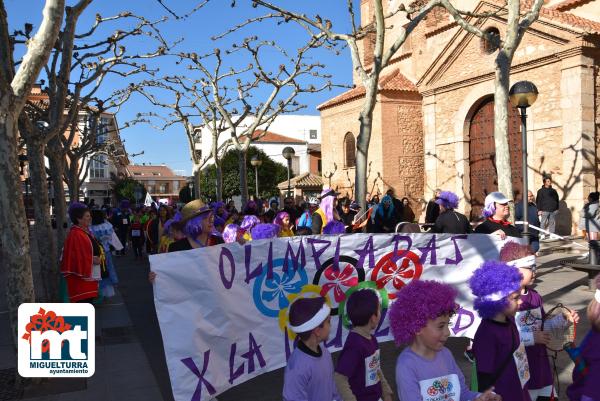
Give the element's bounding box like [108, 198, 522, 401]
[500, 242, 579, 401]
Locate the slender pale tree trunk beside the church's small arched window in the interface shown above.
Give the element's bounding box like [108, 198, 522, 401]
[354, 81, 379, 210]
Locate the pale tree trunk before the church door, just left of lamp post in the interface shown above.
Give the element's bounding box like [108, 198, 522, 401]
[494, 50, 513, 199]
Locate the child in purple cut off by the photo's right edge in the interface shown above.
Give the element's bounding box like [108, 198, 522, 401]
[567, 275, 600, 401]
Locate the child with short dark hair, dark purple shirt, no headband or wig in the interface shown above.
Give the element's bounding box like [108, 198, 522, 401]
[334, 288, 392, 401]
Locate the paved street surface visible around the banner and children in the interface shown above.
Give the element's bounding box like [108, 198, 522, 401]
[0, 239, 592, 401]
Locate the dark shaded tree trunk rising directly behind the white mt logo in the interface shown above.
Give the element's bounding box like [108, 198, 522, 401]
[26, 135, 59, 302]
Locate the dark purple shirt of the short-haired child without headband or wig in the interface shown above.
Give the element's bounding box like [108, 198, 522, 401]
[335, 331, 383, 401]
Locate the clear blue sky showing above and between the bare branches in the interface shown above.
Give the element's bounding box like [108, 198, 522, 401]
[5, 0, 358, 174]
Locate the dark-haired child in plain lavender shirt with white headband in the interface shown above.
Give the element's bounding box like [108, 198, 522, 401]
[283, 297, 342, 401]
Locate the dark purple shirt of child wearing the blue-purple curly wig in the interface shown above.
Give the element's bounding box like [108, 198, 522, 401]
[473, 319, 531, 401]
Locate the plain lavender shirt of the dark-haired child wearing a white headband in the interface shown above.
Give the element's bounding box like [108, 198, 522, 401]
[283, 342, 342, 401]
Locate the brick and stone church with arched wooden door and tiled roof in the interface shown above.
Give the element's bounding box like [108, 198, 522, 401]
[318, 0, 600, 233]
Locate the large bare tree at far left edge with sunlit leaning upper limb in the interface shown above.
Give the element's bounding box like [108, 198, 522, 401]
[0, 0, 65, 344]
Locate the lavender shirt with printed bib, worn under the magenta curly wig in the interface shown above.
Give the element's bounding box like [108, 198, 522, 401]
[396, 347, 479, 401]
